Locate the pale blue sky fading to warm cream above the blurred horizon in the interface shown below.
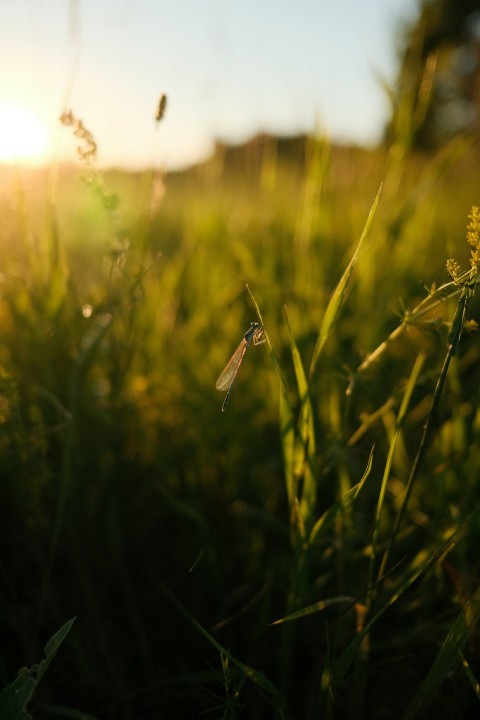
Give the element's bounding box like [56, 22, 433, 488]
[0, 0, 418, 169]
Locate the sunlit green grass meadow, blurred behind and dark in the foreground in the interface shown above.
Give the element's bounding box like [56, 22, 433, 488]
[0, 123, 480, 720]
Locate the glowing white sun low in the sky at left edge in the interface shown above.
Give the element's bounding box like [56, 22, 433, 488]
[0, 104, 49, 164]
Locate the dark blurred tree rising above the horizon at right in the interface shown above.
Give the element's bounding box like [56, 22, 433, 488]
[387, 0, 480, 148]
